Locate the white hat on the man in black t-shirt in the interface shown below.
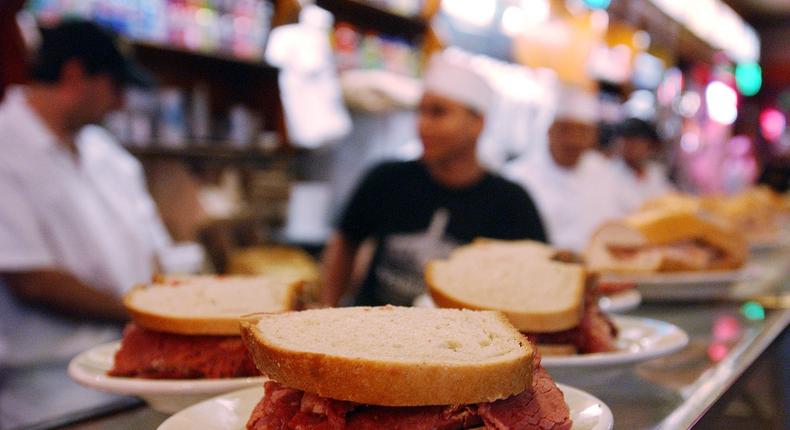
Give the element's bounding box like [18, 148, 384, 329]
[423, 53, 494, 115]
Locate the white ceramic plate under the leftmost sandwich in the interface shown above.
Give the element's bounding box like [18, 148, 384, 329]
[69, 342, 266, 414]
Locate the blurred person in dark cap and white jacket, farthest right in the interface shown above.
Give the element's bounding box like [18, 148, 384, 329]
[613, 118, 674, 212]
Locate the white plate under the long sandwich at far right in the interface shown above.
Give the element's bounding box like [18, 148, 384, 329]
[601, 266, 761, 300]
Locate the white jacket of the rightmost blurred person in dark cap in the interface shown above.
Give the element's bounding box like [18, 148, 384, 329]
[612, 158, 674, 213]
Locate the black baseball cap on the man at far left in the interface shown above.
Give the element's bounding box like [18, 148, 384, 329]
[31, 19, 156, 88]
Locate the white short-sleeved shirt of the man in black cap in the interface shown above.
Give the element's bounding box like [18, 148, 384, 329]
[0, 87, 156, 364]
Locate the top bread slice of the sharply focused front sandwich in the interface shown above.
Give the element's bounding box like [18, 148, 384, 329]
[241, 306, 534, 406]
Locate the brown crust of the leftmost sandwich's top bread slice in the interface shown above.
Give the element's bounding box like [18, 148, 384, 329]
[123, 281, 304, 336]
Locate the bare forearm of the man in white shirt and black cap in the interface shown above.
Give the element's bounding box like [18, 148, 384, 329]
[3, 269, 128, 321]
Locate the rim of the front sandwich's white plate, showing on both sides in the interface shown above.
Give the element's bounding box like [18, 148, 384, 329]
[157, 383, 614, 430]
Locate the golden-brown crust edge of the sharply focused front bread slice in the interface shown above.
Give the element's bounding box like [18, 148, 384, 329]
[241, 315, 535, 406]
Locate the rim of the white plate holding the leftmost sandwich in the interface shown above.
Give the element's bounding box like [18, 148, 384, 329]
[68, 341, 266, 396]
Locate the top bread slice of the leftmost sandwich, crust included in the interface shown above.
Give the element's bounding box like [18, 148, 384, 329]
[124, 276, 303, 335]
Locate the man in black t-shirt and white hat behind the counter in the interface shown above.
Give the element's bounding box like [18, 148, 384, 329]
[321, 54, 546, 306]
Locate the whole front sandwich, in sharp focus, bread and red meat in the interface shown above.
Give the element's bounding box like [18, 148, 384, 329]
[241, 306, 572, 430]
